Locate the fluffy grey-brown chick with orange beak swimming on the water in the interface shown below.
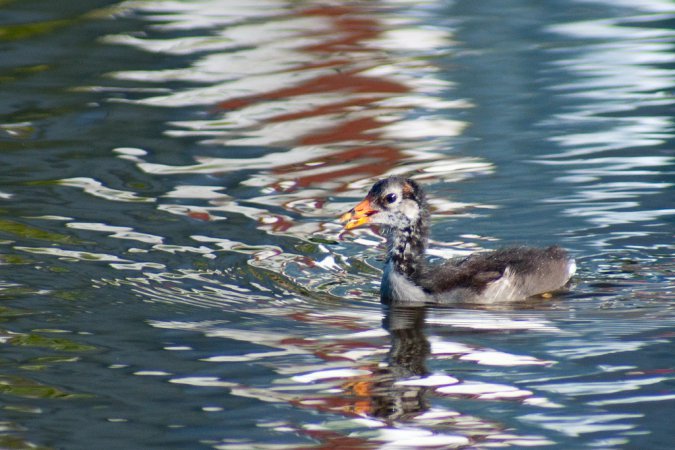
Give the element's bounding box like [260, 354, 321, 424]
[340, 177, 576, 304]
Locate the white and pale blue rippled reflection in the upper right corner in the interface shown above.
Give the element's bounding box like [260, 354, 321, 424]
[537, 8, 675, 247]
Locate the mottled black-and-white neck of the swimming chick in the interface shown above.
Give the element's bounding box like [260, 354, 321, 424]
[387, 220, 427, 278]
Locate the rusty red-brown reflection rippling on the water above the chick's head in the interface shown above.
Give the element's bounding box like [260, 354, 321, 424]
[218, 4, 420, 187]
